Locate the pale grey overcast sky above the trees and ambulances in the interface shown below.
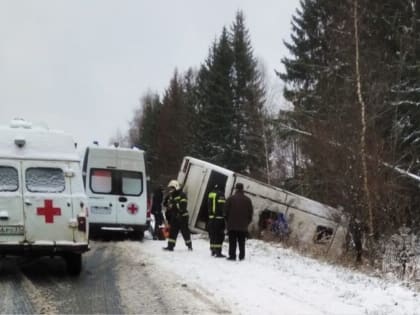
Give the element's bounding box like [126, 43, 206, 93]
[0, 0, 299, 152]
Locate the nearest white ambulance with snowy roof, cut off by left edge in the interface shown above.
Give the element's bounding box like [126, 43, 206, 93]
[0, 119, 89, 275]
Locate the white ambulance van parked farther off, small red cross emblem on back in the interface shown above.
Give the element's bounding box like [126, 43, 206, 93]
[83, 146, 147, 240]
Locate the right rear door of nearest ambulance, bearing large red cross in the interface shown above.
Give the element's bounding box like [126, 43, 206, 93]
[22, 161, 74, 242]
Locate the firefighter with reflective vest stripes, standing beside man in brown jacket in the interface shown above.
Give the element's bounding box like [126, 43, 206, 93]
[207, 185, 226, 257]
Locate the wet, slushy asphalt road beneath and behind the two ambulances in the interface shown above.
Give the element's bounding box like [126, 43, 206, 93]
[0, 241, 230, 314]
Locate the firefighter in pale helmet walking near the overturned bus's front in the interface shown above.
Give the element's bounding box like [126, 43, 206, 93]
[163, 180, 192, 251]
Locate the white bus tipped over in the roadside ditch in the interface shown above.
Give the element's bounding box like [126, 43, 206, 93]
[178, 156, 348, 257]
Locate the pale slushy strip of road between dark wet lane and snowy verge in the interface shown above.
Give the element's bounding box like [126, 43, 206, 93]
[113, 242, 235, 314]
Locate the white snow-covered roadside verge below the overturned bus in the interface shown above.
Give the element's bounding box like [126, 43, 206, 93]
[121, 234, 420, 315]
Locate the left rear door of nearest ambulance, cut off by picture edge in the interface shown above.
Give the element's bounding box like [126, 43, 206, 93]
[0, 159, 25, 244]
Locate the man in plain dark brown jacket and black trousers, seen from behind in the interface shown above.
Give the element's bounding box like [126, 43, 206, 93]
[225, 183, 254, 260]
